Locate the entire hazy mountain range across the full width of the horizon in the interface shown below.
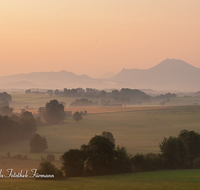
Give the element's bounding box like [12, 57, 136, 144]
[0, 59, 200, 91]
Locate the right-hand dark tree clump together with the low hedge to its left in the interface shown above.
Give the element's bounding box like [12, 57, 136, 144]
[132, 130, 200, 171]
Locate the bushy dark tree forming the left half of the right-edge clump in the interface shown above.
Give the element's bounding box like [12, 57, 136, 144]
[159, 136, 188, 169]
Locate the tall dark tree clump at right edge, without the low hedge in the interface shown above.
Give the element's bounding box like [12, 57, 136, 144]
[159, 130, 200, 169]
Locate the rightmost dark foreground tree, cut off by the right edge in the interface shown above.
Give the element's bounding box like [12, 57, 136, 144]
[178, 130, 200, 161]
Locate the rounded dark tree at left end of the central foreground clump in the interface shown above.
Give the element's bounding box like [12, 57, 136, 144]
[62, 149, 84, 177]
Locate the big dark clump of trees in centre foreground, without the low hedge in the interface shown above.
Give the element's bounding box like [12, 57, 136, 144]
[62, 135, 132, 177]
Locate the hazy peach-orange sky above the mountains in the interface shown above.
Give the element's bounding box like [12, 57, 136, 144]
[0, 0, 200, 77]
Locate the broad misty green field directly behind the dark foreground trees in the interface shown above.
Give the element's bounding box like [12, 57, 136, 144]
[0, 106, 200, 160]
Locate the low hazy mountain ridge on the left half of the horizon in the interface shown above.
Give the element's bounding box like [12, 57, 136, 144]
[0, 71, 108, 89]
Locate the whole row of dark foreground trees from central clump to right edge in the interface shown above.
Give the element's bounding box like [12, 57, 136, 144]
[58, 130, 200, 177]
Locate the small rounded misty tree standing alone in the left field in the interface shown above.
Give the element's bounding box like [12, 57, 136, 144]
[29, 133, 48, 153]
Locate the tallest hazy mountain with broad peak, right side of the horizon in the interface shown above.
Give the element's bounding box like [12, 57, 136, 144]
[110, 59, 200, 91]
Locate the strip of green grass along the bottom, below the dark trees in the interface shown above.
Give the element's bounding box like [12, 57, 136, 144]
[0, 170, 200, 190]
